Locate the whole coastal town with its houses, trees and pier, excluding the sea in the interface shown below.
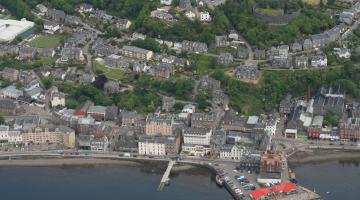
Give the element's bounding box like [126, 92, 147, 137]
[0, 0, 360, 200]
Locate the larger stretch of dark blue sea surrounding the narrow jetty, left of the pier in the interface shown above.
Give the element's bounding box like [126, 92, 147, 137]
[0, 166, 233, 200]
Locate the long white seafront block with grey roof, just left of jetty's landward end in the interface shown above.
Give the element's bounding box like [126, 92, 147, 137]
[139, 135, 180, 156]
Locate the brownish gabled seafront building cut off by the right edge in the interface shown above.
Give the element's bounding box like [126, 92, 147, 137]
[340, 118, 360, 141]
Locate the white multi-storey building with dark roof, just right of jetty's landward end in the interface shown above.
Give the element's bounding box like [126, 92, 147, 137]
[183, 127, 212, 145]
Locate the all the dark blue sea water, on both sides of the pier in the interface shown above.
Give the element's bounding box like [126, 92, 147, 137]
[0, 160, 360, 200]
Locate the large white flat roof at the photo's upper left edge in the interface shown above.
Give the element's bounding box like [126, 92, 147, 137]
[0, 19, 34, 41]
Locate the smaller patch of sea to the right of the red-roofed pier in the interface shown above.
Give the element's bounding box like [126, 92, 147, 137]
[294, 159, 360, 200]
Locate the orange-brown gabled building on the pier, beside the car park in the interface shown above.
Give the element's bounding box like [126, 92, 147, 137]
[260, 154, 283, 173]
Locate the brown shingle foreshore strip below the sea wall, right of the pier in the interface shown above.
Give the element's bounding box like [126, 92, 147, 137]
[288, 150, 360, 165]
